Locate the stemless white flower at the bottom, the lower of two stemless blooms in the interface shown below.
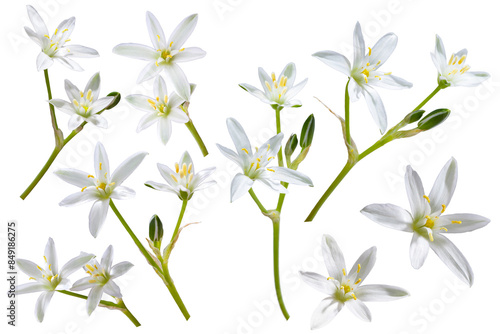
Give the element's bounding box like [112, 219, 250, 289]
[300, 234, 409, 329]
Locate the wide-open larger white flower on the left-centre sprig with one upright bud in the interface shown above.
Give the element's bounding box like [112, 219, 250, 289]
[54, 142, 147, 237]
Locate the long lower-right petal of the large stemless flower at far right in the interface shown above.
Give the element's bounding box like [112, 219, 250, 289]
[430, 233, 474, 286]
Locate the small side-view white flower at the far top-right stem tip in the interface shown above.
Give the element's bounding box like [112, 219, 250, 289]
[431, 35, 490, 87]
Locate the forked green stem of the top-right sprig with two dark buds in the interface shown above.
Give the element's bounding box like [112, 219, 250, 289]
[305, 85, 446, 222]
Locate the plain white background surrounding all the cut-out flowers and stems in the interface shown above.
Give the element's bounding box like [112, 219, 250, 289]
[0, 0, 500, 334]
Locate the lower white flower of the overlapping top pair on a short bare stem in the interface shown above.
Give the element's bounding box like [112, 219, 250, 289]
[125, 76, 189, 145]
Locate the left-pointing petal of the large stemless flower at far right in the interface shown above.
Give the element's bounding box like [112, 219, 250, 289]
[361, 204, 413, 232]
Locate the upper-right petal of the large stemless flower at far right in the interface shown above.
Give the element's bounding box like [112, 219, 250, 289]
[429, 158, 458, 212]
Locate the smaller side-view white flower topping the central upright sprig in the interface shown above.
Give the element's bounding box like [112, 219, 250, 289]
[240, 63, 307, 108]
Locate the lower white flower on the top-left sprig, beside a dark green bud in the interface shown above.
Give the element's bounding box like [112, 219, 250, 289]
[49, 72, 114, 130]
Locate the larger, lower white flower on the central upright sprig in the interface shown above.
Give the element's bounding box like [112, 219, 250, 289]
[217, 118, 313, 202]
